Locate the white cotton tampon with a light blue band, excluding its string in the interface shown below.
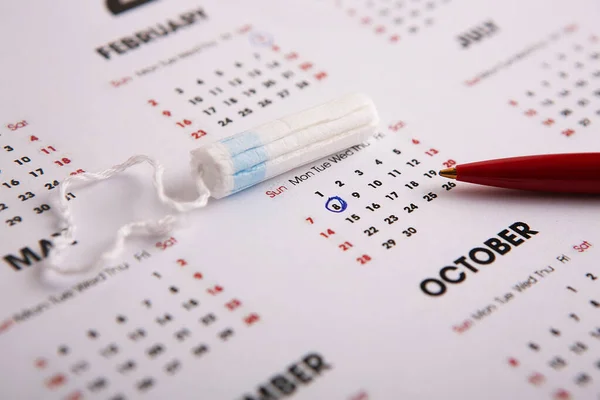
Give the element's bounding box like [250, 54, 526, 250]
[191, 94, 379, 199]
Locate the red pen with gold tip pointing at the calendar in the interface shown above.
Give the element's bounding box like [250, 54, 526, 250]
[439, 153, 600, 194]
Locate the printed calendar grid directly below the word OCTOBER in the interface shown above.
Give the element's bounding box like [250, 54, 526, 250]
[505, 248, 600, 400]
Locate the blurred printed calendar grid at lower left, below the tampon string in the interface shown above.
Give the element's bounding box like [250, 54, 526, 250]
[32, 250, 261, 400]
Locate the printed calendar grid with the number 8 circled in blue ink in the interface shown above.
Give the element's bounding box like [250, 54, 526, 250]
[296, 121, 457, 266]
